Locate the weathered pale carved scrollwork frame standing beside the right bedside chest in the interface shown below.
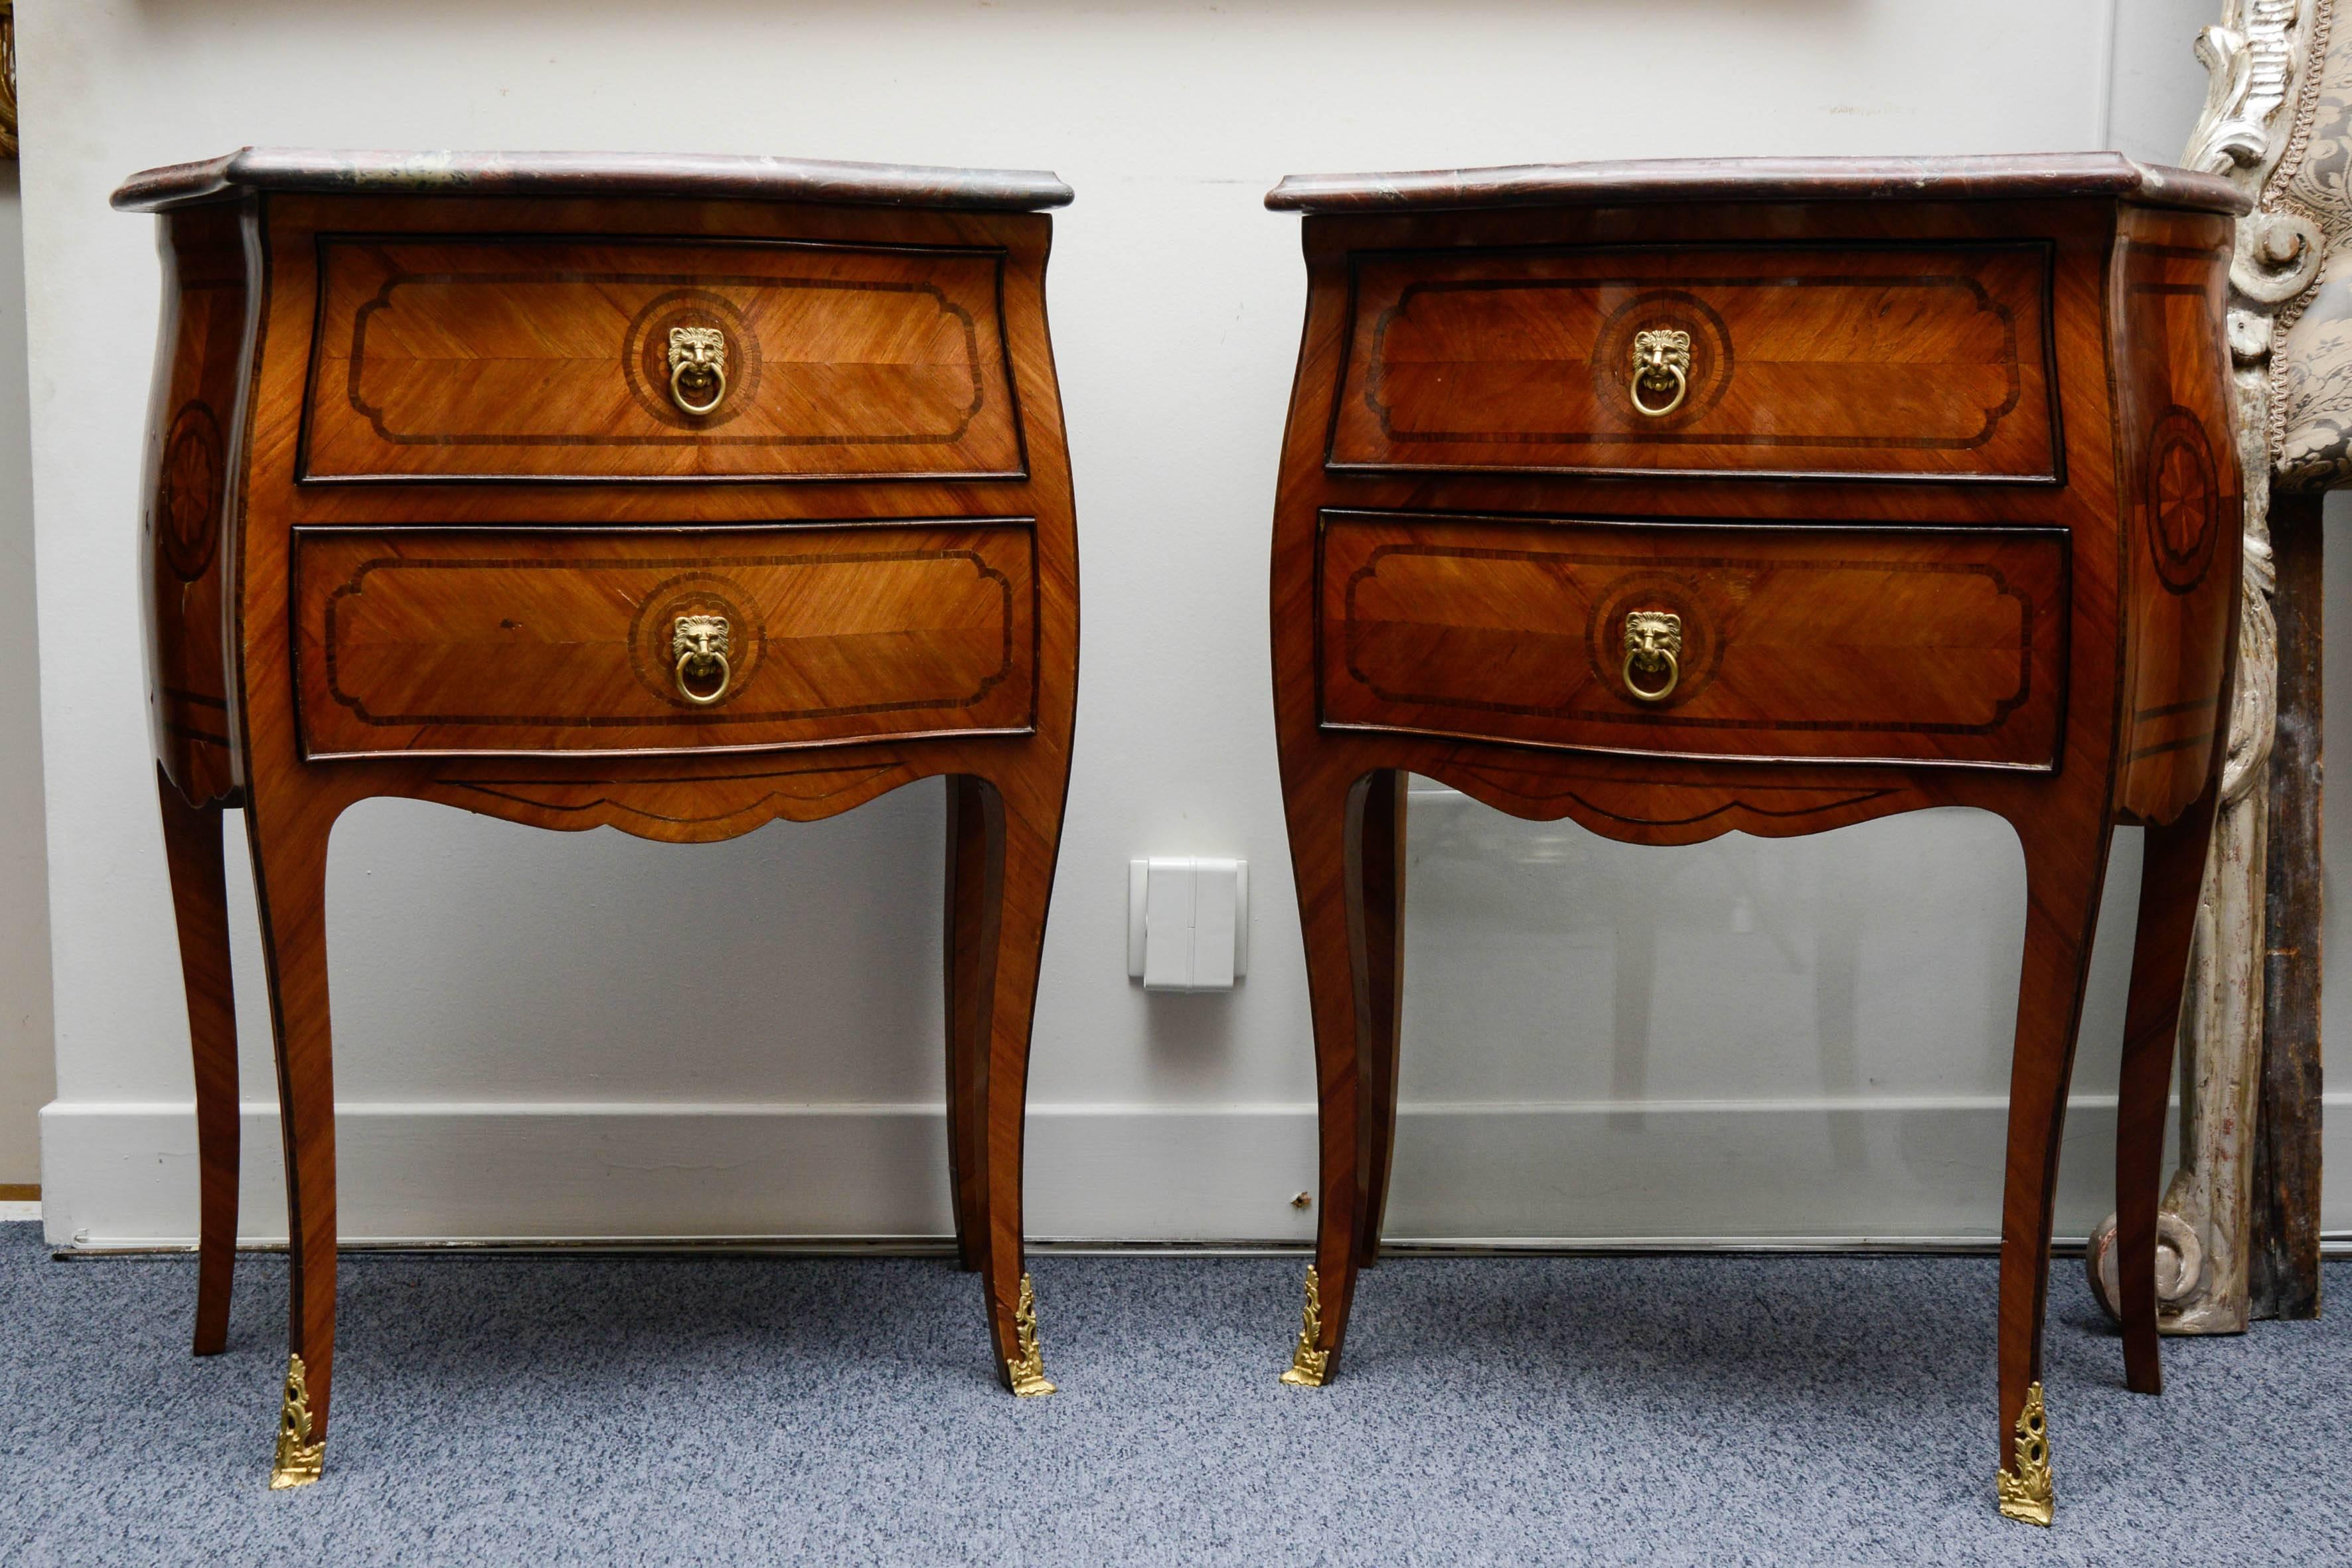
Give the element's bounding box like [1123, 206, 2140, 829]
[2091, 0, 2323, 1333]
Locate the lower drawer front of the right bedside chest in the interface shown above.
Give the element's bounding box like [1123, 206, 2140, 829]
[1317, 510, 2067, 769]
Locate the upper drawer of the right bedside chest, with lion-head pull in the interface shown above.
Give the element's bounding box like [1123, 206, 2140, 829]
[1329, 242, 2061, 482]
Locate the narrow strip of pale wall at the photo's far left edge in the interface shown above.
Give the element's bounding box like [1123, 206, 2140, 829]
[0, 162, 56, 1187]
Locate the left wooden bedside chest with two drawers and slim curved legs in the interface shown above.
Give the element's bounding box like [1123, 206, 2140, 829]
[116, 151, 1077, 1486]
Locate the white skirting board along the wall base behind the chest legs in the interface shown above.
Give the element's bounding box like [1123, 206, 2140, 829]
[42, 1093, 2352, 1251]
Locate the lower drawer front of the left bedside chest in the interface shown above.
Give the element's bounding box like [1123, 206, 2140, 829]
[294, 522, 1037, 757]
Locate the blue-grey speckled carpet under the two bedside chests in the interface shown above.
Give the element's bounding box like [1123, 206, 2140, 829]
[0, 1225, 2352, 1568]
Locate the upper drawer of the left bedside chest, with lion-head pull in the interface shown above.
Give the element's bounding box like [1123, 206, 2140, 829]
[299, 235, 1028, 479]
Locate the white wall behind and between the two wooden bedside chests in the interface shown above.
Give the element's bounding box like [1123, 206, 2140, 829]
[21, 0, 2343, 1246]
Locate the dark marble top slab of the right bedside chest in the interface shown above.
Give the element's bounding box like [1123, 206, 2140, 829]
[1265, 153, 2251, 212]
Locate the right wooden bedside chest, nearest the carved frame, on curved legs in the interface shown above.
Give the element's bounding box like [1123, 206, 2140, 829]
[1268, 155, 2244, 1523]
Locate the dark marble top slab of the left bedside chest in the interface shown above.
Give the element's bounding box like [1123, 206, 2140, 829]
[113, 148, 1070, 212]
